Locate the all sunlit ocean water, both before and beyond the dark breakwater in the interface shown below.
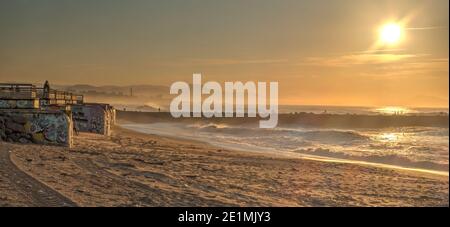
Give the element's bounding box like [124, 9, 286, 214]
[118, 106, 449, 174]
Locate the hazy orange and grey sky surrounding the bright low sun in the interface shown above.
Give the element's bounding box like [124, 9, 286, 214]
[0, 0, 449, 107]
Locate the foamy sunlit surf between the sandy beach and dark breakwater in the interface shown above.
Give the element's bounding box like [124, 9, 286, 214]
[124, 123, 449, 172]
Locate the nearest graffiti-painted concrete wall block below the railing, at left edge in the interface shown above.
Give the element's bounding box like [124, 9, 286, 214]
[0, 111, 72, 146]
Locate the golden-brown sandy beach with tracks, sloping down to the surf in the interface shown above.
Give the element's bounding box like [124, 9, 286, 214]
[0, 126, 449, 206]
